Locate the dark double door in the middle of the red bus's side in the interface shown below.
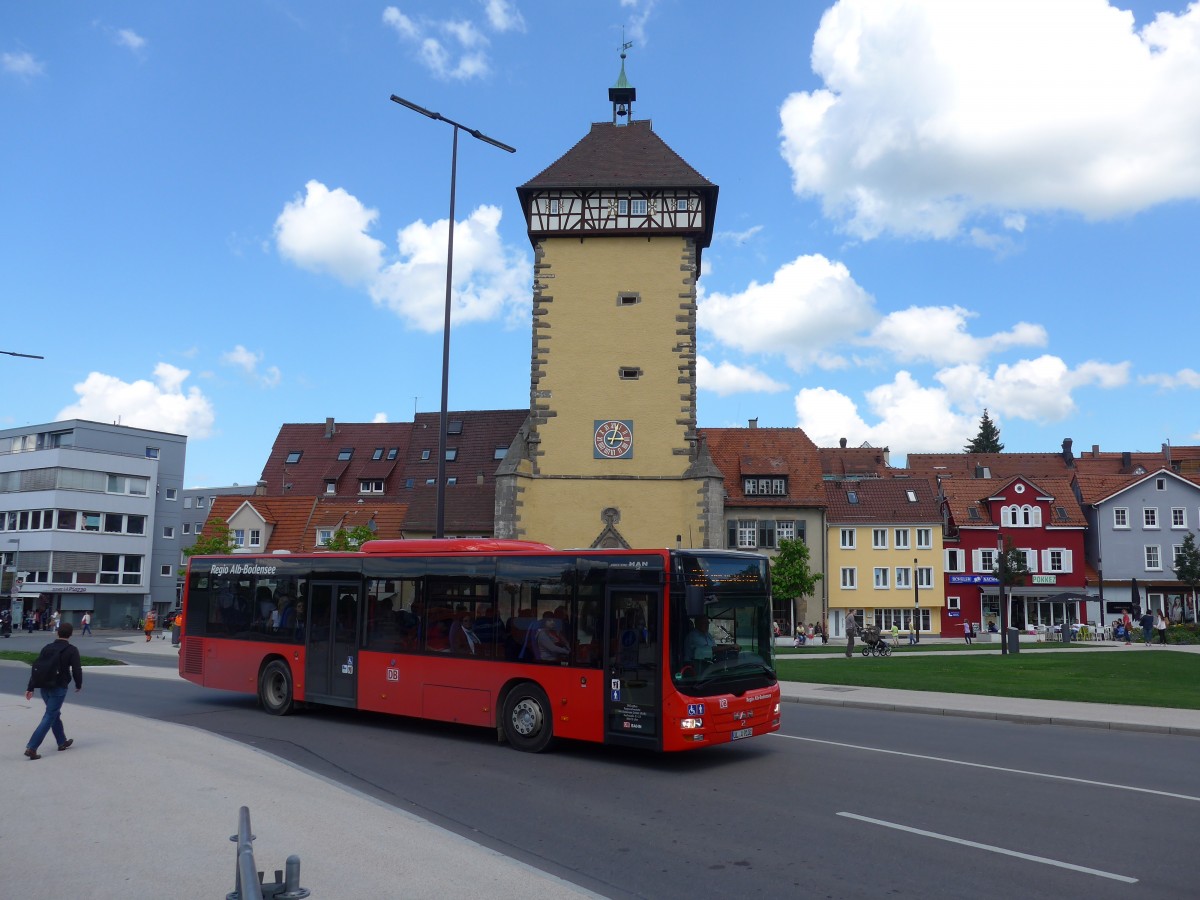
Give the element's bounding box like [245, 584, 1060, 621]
[305, 581, 361, 706]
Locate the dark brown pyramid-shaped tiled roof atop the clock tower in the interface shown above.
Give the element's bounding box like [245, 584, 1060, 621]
[517, 120, 714, 192]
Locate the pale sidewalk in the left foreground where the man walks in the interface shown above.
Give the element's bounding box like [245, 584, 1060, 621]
[0, 637, 596, 900]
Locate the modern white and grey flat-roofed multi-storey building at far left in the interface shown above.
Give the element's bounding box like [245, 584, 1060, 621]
[0, 419, 187, 628]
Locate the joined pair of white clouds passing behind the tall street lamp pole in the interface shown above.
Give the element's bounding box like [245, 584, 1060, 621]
[275, 181, 533, 332]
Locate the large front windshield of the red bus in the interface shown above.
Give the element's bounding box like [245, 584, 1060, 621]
[670, 553, 775, 695]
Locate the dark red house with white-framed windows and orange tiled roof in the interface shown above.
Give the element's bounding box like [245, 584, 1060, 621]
[938, 475, 1087, 637]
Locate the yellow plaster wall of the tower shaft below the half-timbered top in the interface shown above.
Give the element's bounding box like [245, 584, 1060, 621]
[535, 235, 695, 482]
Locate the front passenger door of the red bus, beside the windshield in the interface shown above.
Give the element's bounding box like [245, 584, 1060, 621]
[604, 587, 662, 748]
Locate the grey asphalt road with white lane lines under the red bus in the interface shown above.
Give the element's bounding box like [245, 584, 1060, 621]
[0, 642, 1200, 899]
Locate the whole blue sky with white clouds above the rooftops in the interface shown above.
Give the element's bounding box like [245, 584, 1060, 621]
[0, 0, 1200, 486]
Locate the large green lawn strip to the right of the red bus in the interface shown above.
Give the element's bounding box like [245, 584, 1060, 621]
[775, 650, 1200, 709]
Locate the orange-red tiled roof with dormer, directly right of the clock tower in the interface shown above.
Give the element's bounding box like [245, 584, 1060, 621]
[697, 428, 826, 508]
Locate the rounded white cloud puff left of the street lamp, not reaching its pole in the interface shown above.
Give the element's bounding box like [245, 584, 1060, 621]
[275, 181, 384, 284]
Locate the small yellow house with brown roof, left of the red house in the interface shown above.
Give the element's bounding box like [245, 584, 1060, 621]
[824, 478, 946, 640]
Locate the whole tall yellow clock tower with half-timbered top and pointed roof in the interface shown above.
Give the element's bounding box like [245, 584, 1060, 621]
[496, 62, 724, 547]
